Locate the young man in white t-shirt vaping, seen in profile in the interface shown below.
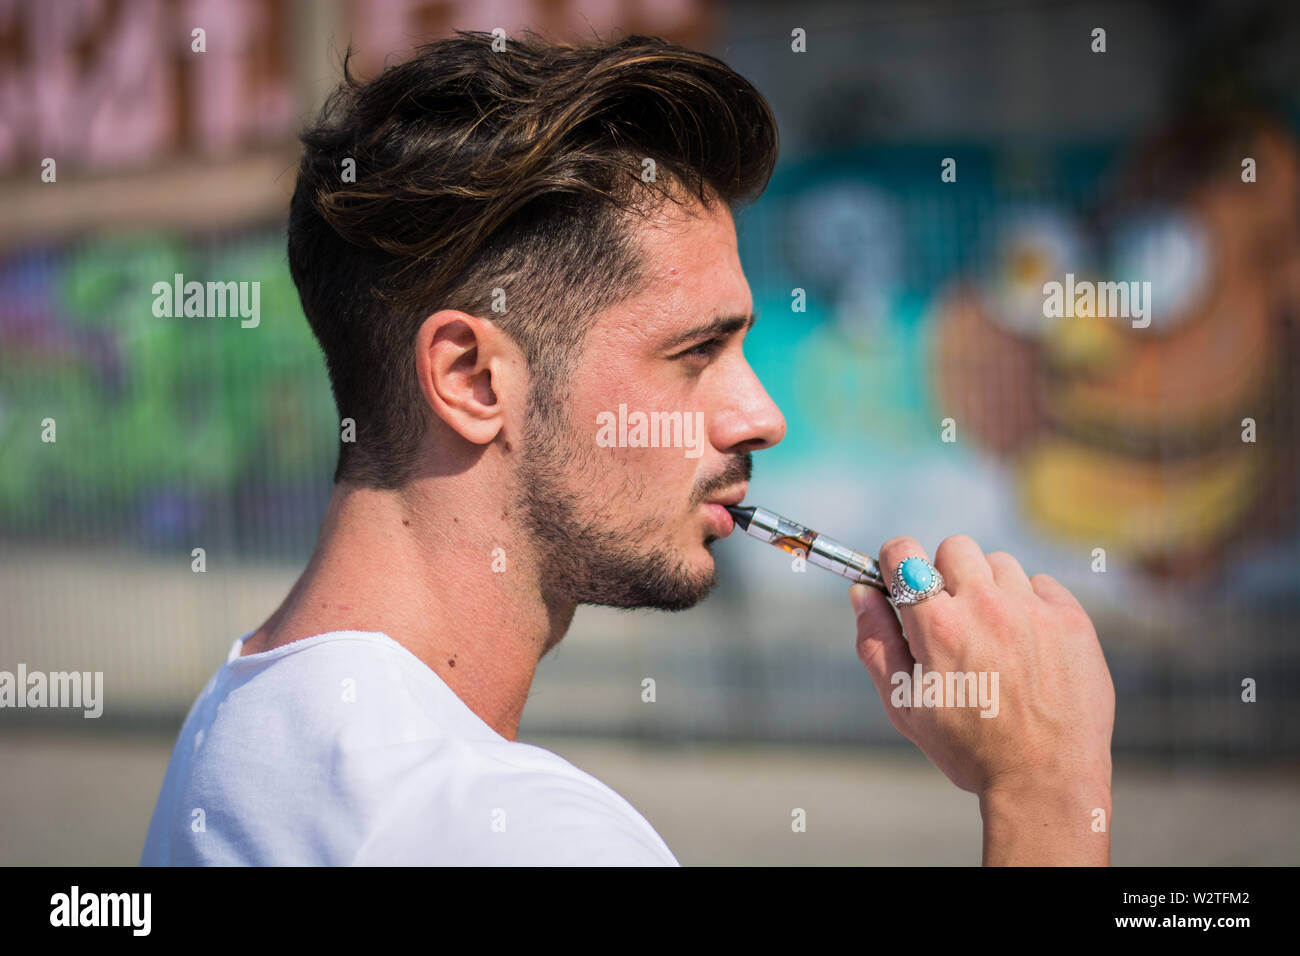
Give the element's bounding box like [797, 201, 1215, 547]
[142, 34, 1114, 865]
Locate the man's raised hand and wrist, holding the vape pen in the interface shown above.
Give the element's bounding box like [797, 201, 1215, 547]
[850, 535, 1115, 865]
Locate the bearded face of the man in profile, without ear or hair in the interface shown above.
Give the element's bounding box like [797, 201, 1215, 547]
[517, 203, 785, 610]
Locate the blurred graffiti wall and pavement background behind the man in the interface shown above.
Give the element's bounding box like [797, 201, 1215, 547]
[0, 0, 1300, 865]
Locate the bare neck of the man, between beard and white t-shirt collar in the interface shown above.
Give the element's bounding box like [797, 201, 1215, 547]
[243, 475, 575, 740]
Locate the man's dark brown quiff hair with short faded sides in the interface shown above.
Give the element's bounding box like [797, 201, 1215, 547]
[289, 31, 777, 488]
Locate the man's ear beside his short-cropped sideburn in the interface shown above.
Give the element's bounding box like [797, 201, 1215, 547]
[415, 308, 525, 445]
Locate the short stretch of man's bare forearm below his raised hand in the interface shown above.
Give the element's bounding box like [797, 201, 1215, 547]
[979, 779, 1110, 866]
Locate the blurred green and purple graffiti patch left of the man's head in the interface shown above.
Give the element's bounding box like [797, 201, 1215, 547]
[0, 227, 335, 529]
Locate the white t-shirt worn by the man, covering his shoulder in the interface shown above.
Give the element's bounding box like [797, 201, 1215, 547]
[140, 631, 679, 866]
